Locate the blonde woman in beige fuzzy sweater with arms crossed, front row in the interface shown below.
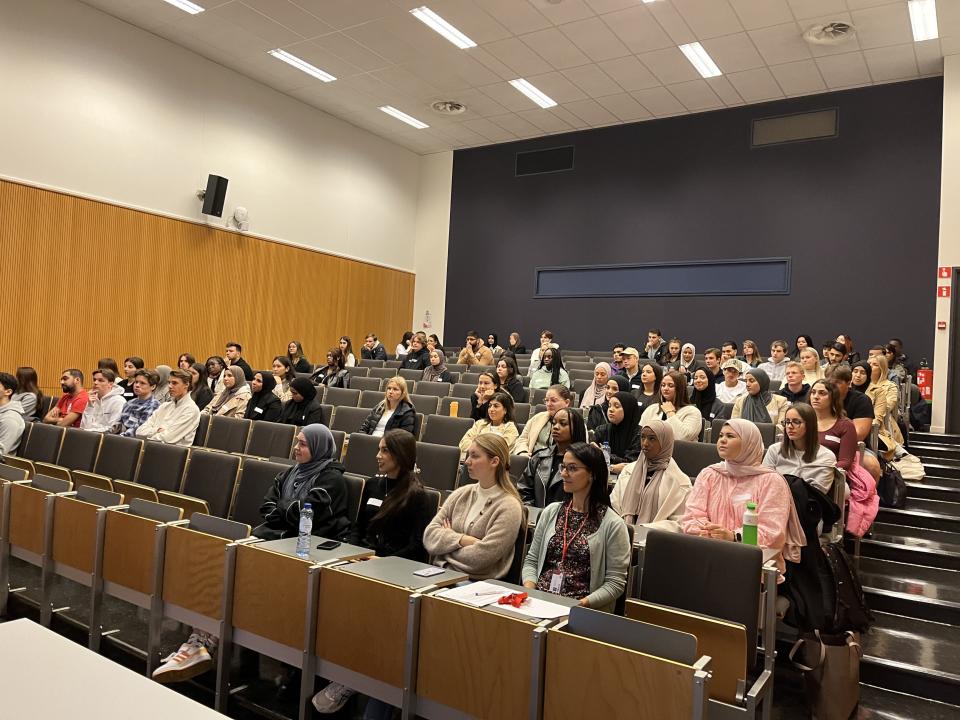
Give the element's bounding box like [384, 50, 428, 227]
[423, 433, 523, 580]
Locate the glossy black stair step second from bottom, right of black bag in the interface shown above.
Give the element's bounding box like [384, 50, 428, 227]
[859, 557, 960, 626]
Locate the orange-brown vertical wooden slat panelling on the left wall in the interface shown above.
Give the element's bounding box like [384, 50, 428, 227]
[0, 180, 414, 392]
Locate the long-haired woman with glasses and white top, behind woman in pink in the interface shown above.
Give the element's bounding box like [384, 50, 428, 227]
[763, 403, 837, 495]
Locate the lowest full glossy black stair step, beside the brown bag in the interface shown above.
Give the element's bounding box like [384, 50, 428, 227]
[860, 612, 960, 703]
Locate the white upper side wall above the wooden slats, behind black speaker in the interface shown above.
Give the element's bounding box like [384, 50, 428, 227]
[0, 0, 422, 270]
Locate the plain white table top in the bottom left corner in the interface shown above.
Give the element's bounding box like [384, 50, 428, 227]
[0, 620, 225, 720]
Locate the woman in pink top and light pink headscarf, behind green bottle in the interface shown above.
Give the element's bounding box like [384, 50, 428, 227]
[680, 419, 806, 580]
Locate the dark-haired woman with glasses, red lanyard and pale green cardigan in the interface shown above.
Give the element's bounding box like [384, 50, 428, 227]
[522, 443, 632, 612]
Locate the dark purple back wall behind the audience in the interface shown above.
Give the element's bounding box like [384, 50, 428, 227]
[445, 78, 943, 360]
